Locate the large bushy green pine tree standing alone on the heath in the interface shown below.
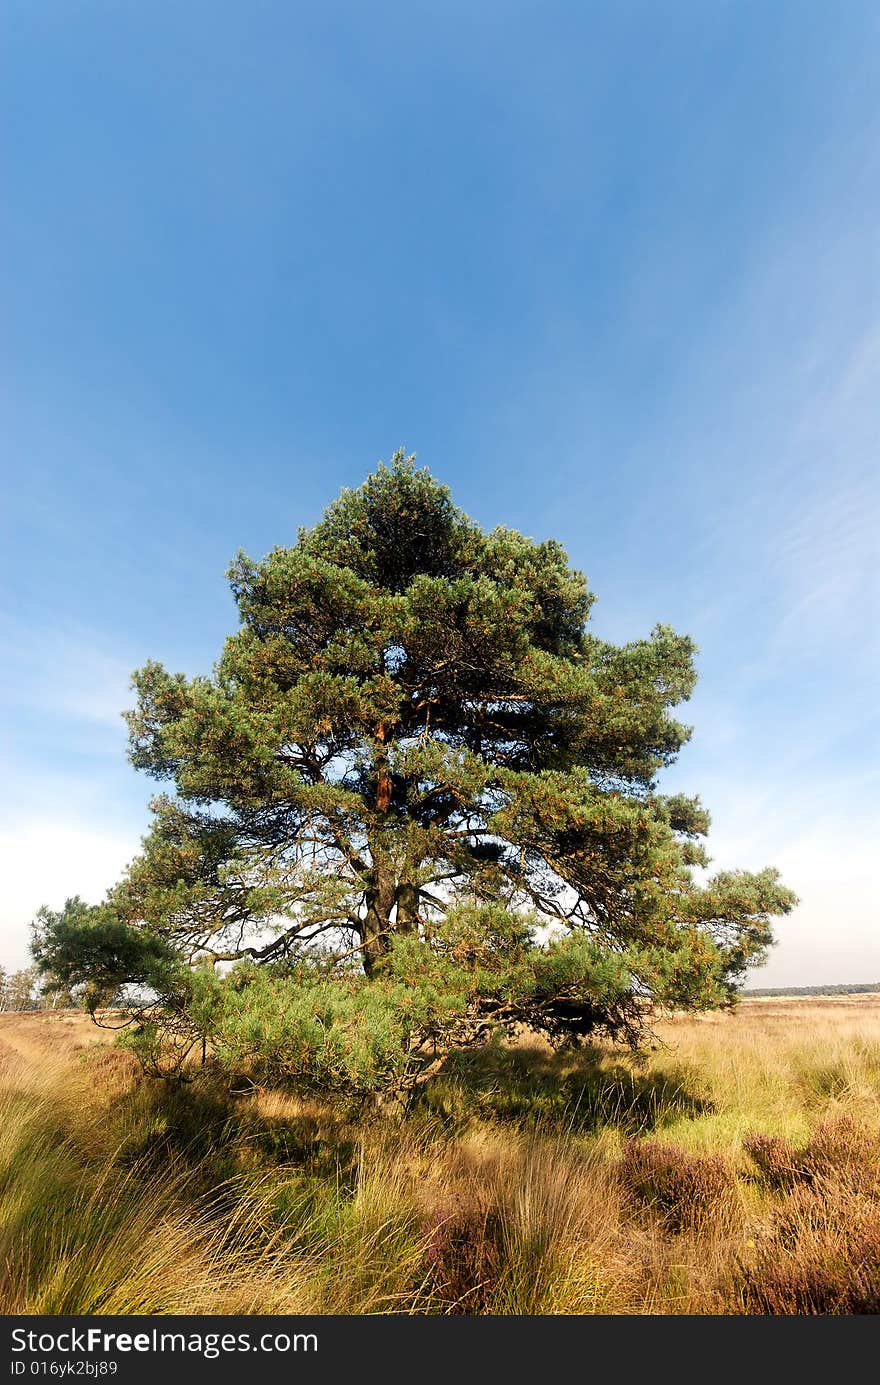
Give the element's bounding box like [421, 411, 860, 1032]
[36, 453, 795, 1089]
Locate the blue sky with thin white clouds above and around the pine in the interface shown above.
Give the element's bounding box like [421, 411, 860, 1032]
[0, 8, 880, 985]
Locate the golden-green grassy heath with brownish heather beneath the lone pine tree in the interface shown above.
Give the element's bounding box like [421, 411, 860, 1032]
[0, 994, 880, 1314]
